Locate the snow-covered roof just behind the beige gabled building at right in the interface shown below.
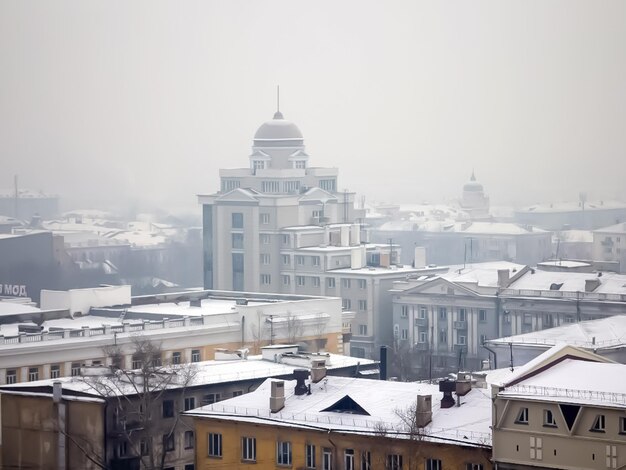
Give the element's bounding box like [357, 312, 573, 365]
[488, 315, 626, 349]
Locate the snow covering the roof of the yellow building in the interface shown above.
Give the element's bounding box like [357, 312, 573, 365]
[188, 376, 491, 445]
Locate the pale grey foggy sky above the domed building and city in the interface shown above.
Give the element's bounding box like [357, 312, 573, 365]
[0, 0, 626, 206]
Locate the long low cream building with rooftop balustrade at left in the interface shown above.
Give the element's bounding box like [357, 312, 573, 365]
[0, 286, 351, 384]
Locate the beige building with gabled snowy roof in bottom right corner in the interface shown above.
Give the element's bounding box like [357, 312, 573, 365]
[492, 346, 626, 470]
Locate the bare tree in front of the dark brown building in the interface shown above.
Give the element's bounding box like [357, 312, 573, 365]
[77, 336, 196, 470]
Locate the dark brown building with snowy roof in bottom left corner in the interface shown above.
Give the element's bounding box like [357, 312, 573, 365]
[0, 346, 377, 470]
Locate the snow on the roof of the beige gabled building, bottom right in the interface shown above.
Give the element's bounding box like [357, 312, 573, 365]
[499, 359, 626, 408]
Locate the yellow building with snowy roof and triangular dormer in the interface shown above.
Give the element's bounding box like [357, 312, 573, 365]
[187, 371, 491, 470]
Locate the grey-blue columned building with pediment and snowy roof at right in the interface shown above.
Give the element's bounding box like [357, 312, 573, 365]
[393, 262, 626, 377]
